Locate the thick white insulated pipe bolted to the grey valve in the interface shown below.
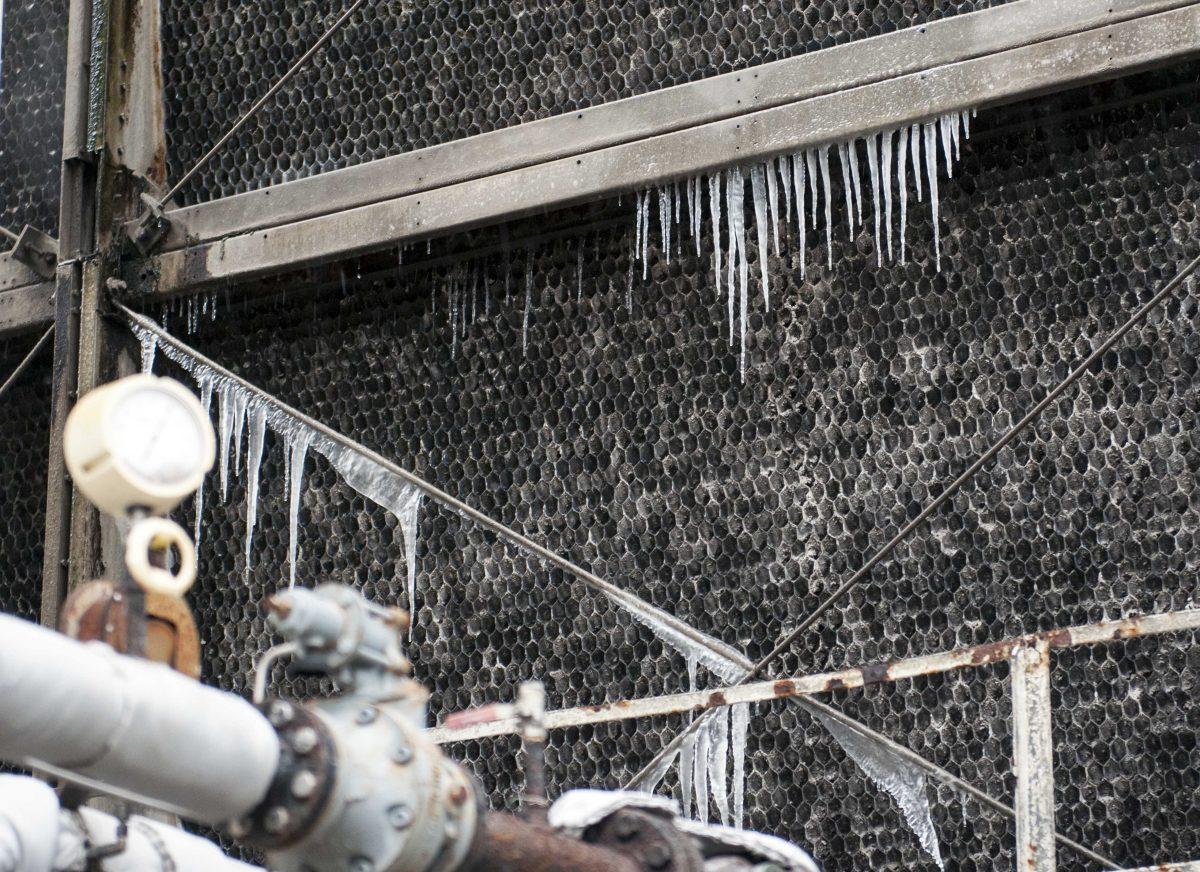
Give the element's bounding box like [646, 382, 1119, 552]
[0, 615, 280, 824]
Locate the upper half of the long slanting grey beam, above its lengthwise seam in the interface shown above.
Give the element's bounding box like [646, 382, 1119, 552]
[145, 0, 1190, 251]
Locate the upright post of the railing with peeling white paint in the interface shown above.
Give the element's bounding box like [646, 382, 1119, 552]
[1012, 641, 1055, 872]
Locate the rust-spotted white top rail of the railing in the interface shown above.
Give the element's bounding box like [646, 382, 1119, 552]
[431, 609, 1200, 742]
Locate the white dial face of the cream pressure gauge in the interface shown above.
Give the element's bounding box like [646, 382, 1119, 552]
[107, 385, 206, 488]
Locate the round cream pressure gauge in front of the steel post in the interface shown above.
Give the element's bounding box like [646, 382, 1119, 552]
[64, 375, 216, 516]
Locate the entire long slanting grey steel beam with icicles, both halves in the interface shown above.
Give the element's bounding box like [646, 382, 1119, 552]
[142, 0, 1200, 294]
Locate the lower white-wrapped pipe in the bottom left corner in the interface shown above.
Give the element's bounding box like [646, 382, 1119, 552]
[0, 775, 263, 872]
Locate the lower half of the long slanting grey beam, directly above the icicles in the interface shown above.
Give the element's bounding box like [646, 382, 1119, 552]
[130, 4, 1200, 294]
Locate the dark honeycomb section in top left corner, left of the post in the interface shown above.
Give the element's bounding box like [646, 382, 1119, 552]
[0, 0, 67, 235]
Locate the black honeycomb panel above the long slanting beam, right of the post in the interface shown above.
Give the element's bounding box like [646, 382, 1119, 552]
[162, 0, 1004, 203]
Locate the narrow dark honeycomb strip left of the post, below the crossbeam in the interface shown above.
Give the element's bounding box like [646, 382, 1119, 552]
[0, 336, 50, 620]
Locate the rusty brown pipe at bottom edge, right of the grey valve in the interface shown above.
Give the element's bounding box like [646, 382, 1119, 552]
[460, 813, 644, 872]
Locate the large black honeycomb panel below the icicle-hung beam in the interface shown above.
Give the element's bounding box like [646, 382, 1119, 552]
[142, 65, 1200, 871]
